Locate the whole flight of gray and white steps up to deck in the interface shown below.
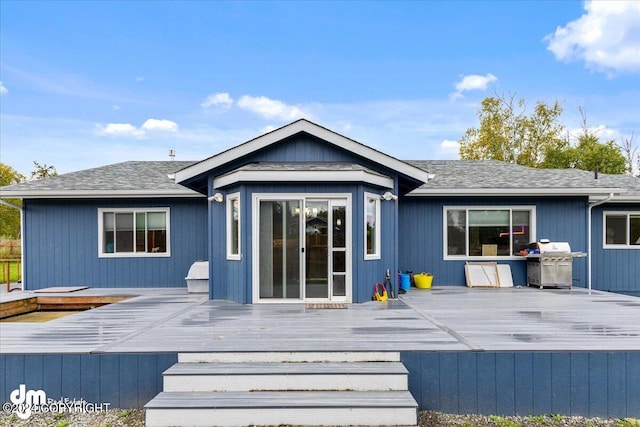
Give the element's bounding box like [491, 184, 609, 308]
[145, 352, 418, 427]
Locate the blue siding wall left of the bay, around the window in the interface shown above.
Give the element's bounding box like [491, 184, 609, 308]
[24, 199, 207, 290]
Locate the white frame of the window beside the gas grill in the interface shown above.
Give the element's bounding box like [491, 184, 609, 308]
[442, 205, 537, 261]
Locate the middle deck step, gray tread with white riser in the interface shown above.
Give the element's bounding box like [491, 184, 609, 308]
[163, 362, 408, 391]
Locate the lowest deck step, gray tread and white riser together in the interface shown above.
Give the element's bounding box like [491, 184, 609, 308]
[145, 391, 417, 427]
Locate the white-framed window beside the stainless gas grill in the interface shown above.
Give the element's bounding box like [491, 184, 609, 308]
[444, 206, 535, 259]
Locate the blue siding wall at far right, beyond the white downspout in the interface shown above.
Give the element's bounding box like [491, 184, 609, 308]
[591, 204, 640, 296]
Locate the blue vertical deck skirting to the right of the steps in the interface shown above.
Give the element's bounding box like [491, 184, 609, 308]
[402, 352, 640, 418]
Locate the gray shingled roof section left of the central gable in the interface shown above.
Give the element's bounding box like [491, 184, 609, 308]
[0, 161, 200, 197]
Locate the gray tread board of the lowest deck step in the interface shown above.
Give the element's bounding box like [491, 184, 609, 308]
[145, 391, 418, 410]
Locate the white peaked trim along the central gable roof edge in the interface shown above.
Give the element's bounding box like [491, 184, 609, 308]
[175, 119, 430, 183]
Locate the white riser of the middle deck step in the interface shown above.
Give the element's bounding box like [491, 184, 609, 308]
[164, 374, 407, 392]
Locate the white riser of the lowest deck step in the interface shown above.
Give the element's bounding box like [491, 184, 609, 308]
[146, 408, 416, 427]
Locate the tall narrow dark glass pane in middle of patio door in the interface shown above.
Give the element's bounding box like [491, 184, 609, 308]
[305, 200, 329, 298]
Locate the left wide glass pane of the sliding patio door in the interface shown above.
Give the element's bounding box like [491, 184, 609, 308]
[259, 200, 300, 299]
